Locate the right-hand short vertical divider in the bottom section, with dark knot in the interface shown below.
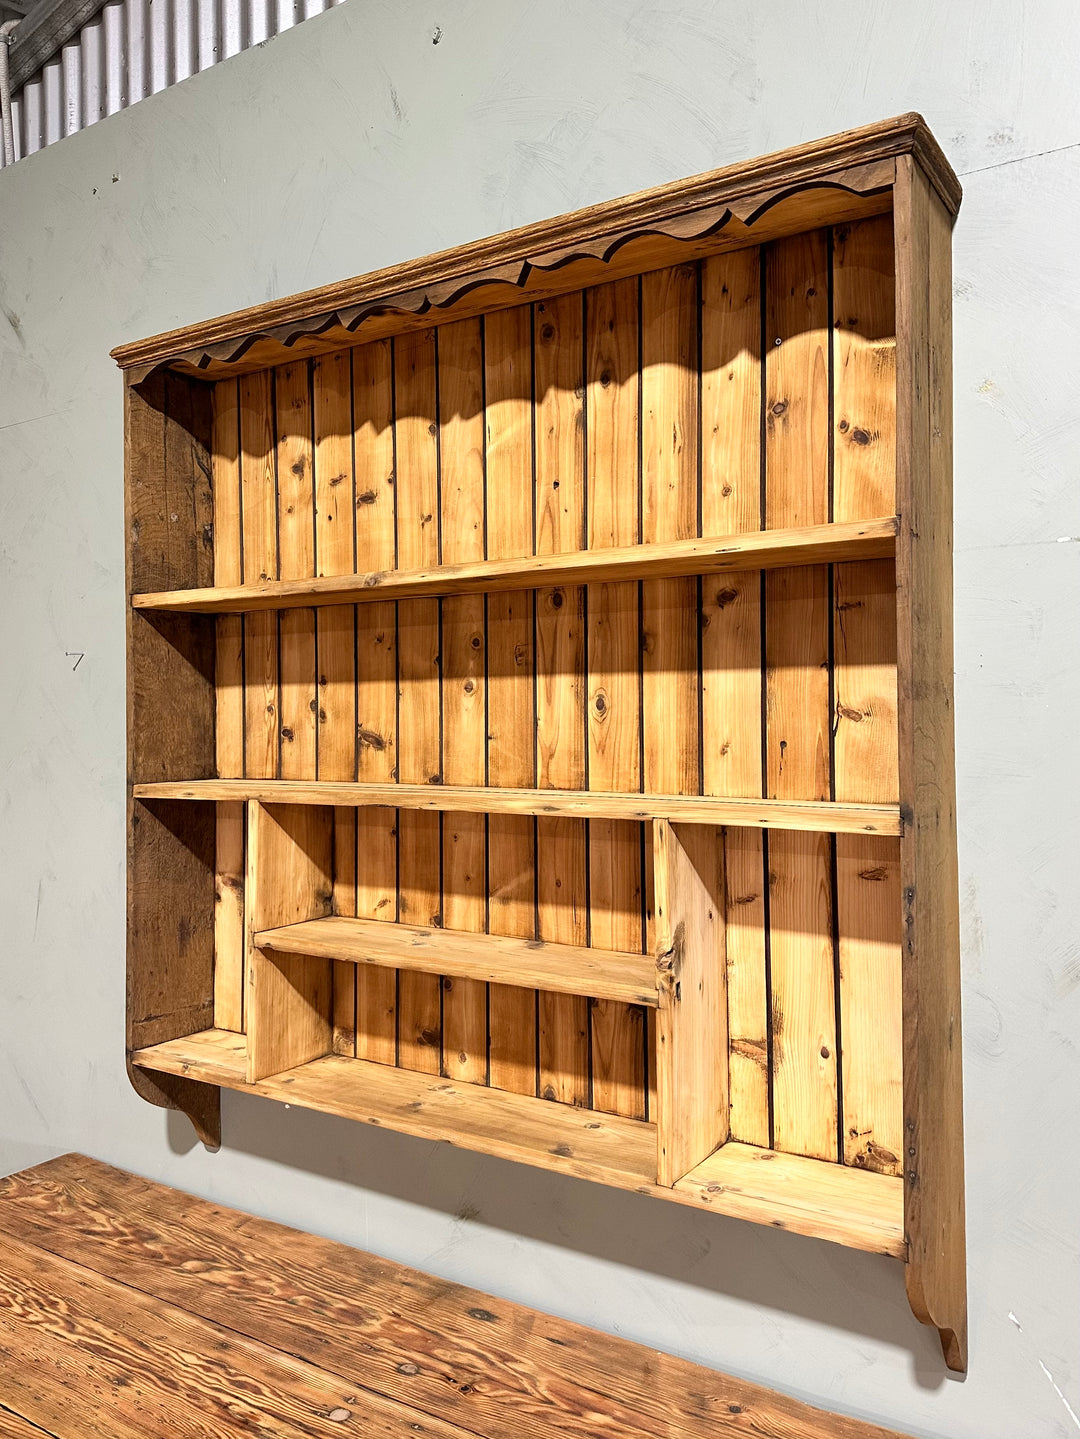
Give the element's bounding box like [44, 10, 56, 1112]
[653, 820, 729, 1184]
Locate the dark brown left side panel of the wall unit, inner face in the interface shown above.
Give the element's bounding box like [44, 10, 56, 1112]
[124, 376, 220, 1145]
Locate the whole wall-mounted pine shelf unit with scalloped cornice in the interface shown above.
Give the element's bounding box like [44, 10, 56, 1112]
[115, 115, 966, 1368]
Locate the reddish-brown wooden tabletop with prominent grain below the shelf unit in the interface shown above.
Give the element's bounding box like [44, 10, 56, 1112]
[0, 1154, 896, 1439]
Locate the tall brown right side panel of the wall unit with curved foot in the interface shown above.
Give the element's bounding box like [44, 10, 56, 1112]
[894, 157, 968, 1370]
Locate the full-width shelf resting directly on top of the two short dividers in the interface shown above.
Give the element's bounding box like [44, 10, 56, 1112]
[132, 780, 902, 835]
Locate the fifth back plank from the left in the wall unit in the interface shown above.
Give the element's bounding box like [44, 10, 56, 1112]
[352, 340, 397, 1065]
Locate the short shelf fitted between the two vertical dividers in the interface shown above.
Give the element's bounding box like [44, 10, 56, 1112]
[255, 915, 657, 1009]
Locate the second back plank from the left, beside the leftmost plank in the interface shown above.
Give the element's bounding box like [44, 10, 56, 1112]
[240, 370, 280, 780]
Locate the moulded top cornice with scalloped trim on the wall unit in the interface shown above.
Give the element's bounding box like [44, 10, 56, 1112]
[112, 114, 961, 381]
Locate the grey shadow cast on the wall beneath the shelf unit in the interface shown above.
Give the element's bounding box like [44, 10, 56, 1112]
[167, 1091, 962, 1389]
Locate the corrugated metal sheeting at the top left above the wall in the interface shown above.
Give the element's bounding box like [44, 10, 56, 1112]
[0, 0, 341, 160]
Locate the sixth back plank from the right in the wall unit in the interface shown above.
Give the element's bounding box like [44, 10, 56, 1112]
[534, 294, 588, 1105]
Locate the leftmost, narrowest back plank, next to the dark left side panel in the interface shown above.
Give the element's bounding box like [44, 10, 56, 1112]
[211, 380, 244, 1032]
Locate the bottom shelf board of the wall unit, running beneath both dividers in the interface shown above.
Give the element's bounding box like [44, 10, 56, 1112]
[132, 1029, 907, 1259]
